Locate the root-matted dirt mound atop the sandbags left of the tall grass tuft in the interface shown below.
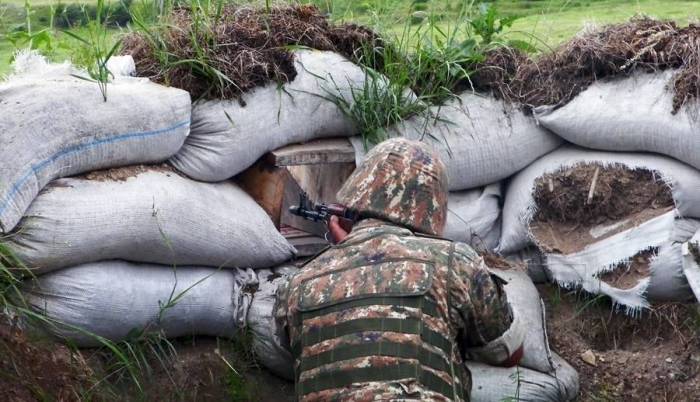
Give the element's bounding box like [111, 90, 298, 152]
[123, 5, 380, 99]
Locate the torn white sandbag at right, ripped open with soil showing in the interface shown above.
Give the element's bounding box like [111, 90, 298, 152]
[504, 149, 700, 314]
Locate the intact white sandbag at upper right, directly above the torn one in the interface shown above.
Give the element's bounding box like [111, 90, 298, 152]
[535, 70, 700, 169]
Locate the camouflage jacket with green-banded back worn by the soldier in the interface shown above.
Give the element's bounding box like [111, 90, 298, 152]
[275, 219, 512, 401]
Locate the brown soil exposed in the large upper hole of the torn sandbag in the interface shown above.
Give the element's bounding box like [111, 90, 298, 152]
[530, 164, 674, 254]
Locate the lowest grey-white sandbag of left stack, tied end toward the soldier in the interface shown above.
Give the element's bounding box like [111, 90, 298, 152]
[24, 261, 257, 347]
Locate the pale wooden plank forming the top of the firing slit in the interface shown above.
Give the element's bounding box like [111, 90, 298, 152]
[267, 138, 355, 166]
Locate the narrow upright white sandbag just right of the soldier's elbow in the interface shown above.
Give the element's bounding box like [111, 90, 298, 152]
[490, 269, 556, 373]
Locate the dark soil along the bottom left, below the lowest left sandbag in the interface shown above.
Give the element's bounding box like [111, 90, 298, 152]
[0, 322, 294, 402]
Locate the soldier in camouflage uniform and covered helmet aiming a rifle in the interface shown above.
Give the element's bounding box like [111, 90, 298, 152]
[274, 139, 524, 401]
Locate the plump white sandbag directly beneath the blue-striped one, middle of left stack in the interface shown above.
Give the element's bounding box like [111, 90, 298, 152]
[3, 167, 294, 273]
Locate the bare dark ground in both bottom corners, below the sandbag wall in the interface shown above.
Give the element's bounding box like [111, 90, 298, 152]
[0, 285, 700, 402]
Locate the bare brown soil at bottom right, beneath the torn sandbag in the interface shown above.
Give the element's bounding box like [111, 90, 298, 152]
[538, 285, 700, 402]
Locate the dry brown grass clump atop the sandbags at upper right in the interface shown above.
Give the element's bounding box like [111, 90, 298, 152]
[472, 18, 700, 113]
